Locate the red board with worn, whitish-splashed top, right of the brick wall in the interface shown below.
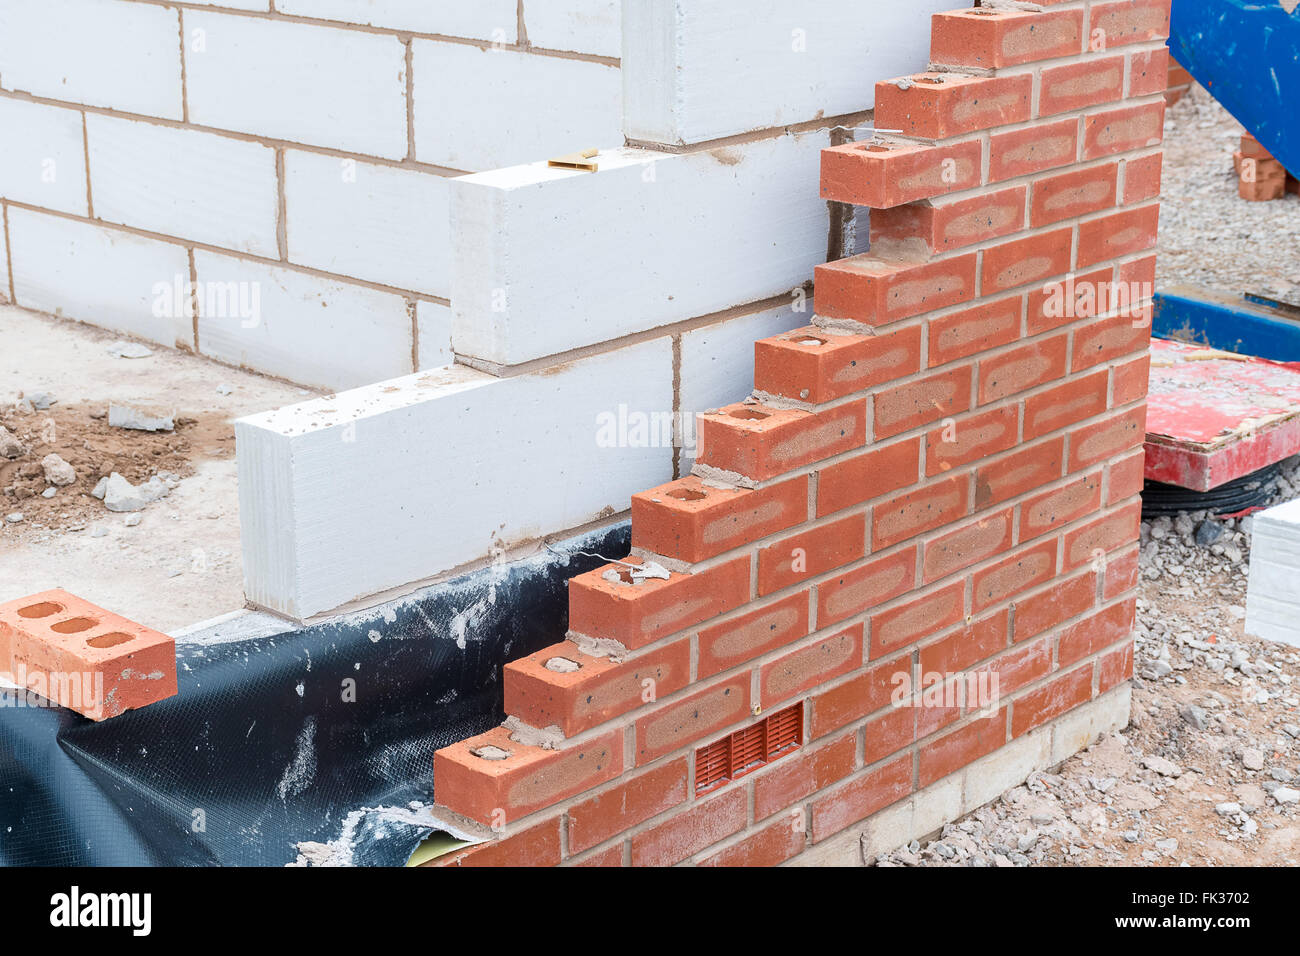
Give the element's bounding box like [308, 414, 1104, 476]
[1147, 338, 1300, 492]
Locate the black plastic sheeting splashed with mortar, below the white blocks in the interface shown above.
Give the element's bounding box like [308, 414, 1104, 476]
[0, 524, 628, 866]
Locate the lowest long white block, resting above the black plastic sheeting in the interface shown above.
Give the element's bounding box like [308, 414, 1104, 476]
[235, 338, 672, 620]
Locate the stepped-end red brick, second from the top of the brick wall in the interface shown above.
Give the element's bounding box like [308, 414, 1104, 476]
[875, 73, 1034, 139]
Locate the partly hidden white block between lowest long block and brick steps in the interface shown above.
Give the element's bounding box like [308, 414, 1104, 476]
[681, 300, 813, 471]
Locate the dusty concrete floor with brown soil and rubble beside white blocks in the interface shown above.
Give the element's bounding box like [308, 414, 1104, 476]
[0, 306, 315, 631]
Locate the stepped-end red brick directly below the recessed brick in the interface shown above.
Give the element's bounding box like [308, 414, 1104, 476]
[814, 252, 976, 326]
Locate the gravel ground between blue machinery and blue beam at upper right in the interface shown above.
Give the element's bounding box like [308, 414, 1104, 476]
[1156, 86, 1300, 306]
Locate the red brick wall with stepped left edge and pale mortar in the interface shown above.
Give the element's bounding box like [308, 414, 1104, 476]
[434, 0, 1169, 865]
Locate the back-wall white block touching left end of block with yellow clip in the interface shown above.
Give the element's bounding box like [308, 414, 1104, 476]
[285, 150, 451, 298]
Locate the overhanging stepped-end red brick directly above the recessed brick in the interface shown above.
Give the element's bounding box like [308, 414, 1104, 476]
[822, 137, 983, 209]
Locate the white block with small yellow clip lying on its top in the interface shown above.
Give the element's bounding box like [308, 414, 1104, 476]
[451, 133, 829, 365]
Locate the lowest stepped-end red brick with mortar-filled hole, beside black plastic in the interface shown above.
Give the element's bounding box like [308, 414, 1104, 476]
[433, 727, 623, 826]
